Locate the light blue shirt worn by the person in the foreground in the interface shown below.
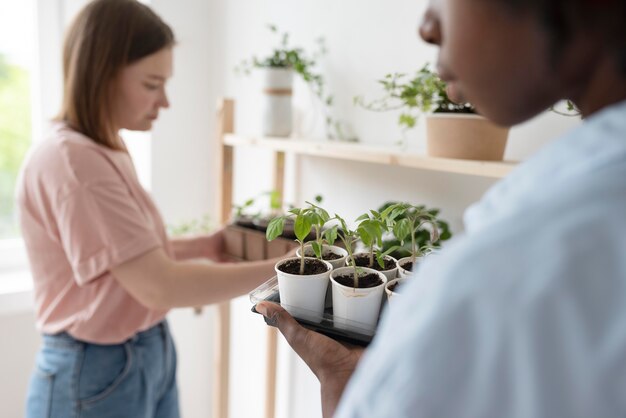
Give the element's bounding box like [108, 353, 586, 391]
[336, 102, 626, 418]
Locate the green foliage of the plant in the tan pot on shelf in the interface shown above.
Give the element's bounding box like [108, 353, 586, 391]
[354, 64, 476, 136]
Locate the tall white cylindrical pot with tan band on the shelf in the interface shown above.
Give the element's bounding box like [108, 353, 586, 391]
[261, 68, 293, 137]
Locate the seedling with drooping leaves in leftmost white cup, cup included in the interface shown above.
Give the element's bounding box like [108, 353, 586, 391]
[266, 208, 332, 322]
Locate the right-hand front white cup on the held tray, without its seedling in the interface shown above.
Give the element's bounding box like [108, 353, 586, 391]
[330, 267, 387, 335]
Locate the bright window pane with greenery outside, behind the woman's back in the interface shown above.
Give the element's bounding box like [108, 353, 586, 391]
[0, 0, 35, 240]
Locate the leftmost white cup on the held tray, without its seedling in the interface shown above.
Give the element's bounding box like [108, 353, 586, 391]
[274, 257, 332, 322]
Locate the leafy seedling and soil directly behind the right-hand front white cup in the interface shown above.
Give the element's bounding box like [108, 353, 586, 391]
[349, 210, 398, 280]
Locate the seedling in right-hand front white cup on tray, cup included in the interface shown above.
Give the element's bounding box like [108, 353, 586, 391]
[330, 215, 387, 335]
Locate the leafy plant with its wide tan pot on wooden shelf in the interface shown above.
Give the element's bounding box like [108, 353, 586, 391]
[355, 64, 509, 161]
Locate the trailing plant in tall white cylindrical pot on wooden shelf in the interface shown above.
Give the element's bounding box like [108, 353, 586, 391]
[235, 25, 355, 140]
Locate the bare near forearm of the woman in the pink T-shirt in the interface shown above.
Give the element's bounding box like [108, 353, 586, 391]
[111, 248, 279, 309]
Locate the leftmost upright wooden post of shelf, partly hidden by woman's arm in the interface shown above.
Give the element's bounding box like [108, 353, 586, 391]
[213, 99, 234, 418]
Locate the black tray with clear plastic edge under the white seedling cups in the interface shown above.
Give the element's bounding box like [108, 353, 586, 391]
[250, 276, 375, 347]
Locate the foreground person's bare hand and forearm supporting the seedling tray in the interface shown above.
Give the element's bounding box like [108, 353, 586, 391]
[256, 302, 363, 417]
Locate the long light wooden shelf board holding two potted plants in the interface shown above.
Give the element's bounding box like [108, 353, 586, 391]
[223, 134, 517, 178]
